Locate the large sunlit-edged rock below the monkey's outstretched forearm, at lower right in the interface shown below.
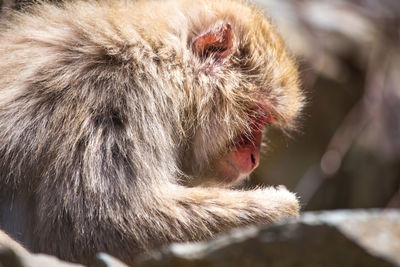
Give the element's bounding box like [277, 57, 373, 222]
[135, 210, 400, 267]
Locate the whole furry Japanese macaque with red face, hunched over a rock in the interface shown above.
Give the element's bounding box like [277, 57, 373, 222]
[0, 0, 303, 265]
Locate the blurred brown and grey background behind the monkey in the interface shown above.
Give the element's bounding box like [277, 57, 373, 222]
[0, 0, 400, 214]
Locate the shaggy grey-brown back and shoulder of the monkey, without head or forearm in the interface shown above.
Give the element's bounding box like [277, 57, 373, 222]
[0, 1, 184, 260]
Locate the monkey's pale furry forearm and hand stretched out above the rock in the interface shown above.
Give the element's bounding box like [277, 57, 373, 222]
[153, 187, 299, 240]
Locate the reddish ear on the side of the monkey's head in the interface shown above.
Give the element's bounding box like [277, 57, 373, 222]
[192, 22, 235, 61]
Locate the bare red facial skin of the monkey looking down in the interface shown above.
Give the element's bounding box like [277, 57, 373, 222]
[216, 107, 273, 184]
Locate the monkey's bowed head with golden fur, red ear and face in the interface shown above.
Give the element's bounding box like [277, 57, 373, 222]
[158, 1, 304, 185]
